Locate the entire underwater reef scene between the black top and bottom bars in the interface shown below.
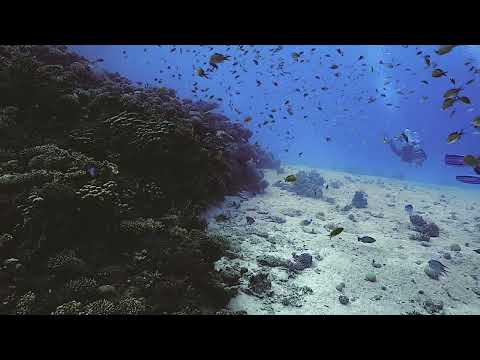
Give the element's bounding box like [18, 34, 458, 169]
[0, 45, 480, 315]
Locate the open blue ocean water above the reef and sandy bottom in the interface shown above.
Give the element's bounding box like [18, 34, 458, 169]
[70, 45, 480, 191]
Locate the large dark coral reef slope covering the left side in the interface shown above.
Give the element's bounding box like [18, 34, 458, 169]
[0, 45, 270, 315]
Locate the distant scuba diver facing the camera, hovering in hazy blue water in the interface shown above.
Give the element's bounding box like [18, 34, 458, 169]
[383, 129, 427, 167]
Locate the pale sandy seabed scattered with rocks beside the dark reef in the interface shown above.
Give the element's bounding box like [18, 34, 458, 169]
[207, 166, 480, 315]
